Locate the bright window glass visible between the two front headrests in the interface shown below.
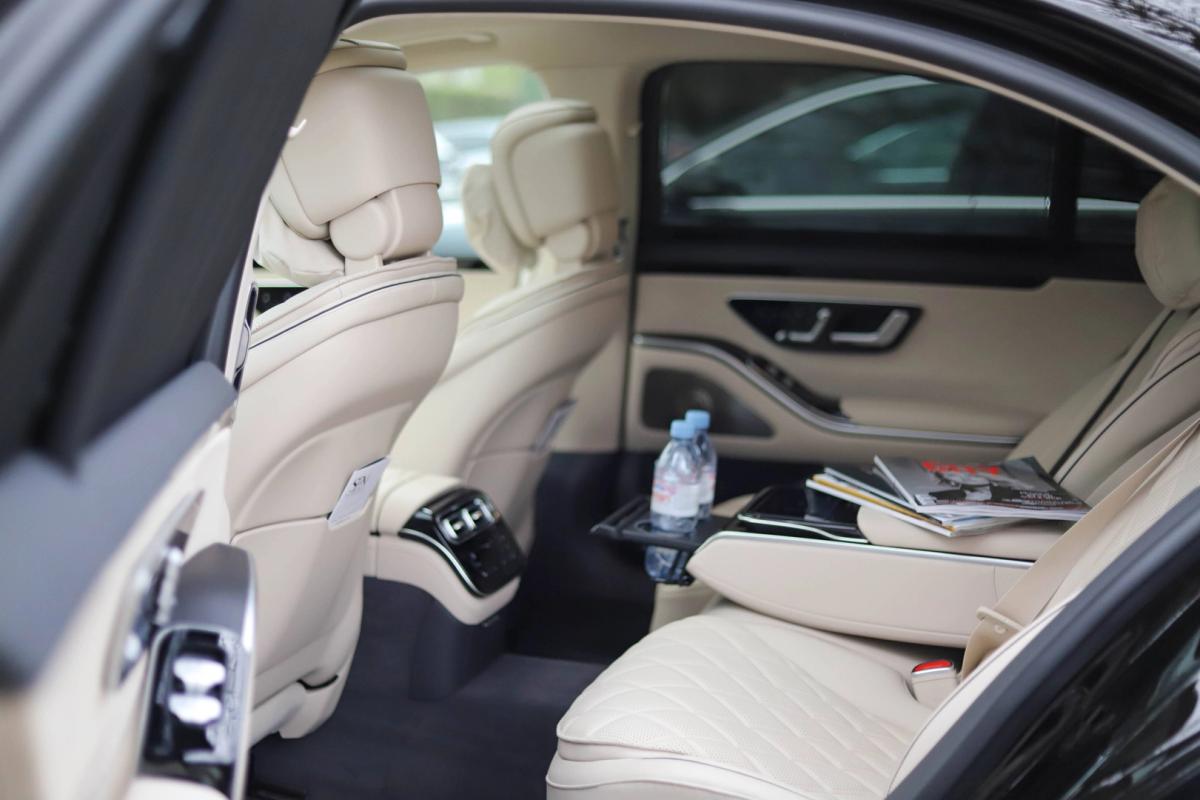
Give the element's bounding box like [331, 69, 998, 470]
[419, 65, 546, 261]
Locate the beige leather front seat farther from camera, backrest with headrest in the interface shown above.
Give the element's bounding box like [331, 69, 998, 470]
[392, 100, 629, 548]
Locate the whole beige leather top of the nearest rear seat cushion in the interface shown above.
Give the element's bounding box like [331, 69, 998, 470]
[550, 613, 930, 800]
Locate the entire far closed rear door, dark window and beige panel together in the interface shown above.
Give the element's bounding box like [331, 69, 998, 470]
[624, 62, 1160, 463]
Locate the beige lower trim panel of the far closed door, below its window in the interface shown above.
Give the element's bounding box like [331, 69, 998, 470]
[625, 273, 1158, 462]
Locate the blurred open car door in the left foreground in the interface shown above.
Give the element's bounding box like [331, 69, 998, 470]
[0, 0, 344, 800]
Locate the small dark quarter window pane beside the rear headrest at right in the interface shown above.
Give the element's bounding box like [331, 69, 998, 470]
[1075, 136, 1163, 245]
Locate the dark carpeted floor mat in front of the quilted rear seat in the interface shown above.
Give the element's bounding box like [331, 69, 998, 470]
[253, 652, 601, 800]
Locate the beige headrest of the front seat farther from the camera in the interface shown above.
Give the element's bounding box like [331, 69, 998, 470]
[492, 100, 619, 264]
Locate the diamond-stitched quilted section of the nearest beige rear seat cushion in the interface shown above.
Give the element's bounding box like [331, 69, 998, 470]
[559, 615, 914, 800]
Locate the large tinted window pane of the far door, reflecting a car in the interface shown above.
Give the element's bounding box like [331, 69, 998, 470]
[659, 64, 1055, 236]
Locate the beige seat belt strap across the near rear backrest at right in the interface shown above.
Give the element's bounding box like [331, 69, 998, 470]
[961, 417, 1200, 676]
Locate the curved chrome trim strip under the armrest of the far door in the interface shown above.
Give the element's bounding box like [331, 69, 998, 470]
[634, 333, 1020, 447]
